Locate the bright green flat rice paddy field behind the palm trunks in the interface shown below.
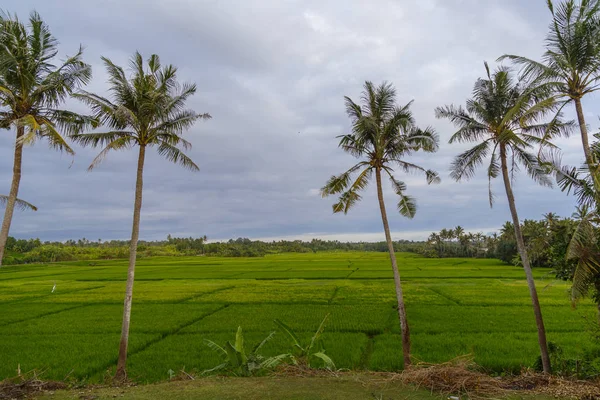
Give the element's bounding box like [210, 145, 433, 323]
[0, 253, 595, 382]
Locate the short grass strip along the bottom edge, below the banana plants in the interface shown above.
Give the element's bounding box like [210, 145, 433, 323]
[41, 375, 550, 400]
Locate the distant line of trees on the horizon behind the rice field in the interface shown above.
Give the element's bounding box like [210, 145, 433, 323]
[5, 213, 578, 272]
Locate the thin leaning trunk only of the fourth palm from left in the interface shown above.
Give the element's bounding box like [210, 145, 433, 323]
[500, 144, 552, 374]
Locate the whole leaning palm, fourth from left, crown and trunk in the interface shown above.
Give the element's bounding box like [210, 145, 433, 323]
[436, 63, 570, 372]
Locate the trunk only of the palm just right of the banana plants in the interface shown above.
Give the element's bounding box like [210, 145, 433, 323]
[375, 168, 411, 368]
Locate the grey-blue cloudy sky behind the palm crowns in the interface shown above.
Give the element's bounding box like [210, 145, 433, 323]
[0, 0, 599, 240]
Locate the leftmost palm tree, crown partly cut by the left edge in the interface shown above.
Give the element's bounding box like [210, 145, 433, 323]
[0, 12, 92, 265]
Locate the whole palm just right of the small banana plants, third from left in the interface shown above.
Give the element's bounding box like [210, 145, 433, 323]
[321, 82, 440, 367]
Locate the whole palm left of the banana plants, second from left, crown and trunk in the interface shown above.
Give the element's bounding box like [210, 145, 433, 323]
[73, 53, 210, 380]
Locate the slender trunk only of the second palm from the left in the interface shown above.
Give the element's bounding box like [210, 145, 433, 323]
[115, 146, 146, 381]
